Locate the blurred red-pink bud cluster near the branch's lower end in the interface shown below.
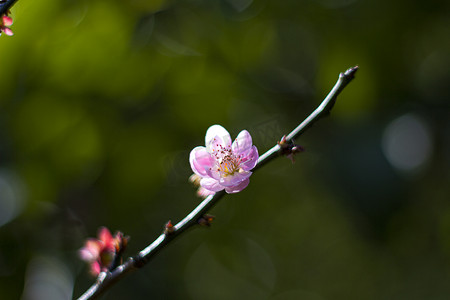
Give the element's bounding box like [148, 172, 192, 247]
[79, 227, 128, 276]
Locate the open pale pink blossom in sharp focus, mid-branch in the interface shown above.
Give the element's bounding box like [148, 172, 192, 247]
[189, 125, 259, 195]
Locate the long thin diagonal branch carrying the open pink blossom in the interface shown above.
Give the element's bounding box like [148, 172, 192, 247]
[78, 66, 358, 300]
